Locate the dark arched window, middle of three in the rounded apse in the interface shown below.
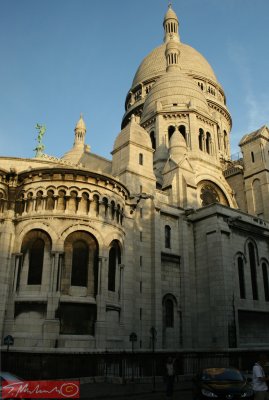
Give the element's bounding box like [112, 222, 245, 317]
[71, 240, 89, 287]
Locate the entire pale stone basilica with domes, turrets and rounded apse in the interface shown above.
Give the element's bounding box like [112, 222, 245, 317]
[0, 6, 269, 360]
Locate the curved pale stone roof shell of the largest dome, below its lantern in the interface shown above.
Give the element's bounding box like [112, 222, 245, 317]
[132, 43, 217, 88]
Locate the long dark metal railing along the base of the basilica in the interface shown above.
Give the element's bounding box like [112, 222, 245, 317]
[1, 349, 262, 381]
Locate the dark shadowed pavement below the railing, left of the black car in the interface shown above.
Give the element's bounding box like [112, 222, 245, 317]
[80, 377, 192, 399]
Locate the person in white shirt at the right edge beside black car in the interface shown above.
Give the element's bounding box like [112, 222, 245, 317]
[252, 354, 269, 400]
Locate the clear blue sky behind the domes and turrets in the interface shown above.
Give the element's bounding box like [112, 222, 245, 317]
[0, 0, 269, 158]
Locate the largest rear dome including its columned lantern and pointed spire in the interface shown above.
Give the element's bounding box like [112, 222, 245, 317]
[122, 5, 229, 129]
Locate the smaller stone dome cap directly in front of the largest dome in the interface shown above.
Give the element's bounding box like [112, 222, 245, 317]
[141, 71, 209, 123]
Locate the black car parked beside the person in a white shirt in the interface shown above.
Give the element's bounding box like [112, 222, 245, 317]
[193, 368, 253, 400]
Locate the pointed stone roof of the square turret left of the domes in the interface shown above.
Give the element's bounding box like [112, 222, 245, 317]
[113, 115, 152, 151]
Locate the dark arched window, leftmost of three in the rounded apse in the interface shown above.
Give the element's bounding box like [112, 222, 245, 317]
[27, 239, 45, 285]
